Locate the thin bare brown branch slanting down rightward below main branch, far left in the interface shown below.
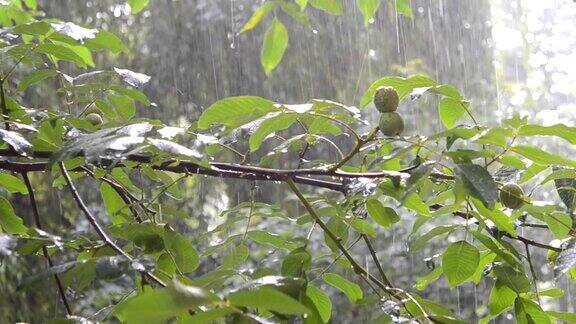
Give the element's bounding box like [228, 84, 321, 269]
[59, 162, 166, 287]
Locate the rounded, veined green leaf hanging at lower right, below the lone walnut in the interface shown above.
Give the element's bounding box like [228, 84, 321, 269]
[442, 241, 480, 287]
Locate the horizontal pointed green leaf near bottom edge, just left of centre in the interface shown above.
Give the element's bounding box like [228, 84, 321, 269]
[228, 287, 309, 314]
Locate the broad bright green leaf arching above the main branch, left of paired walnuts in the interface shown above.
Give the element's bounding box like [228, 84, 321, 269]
[198, 96, 279, 129]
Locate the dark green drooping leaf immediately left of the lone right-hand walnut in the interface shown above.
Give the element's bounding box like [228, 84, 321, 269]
[456, 164, 498, 209]
